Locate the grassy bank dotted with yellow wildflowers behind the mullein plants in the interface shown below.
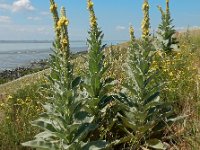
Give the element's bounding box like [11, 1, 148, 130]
[0, 26, 200, 150]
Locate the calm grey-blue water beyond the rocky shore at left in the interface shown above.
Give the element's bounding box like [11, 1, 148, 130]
[0, 41, 123, 70]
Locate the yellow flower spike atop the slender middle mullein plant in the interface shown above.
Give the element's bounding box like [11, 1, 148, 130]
[87, 0, 97, 29]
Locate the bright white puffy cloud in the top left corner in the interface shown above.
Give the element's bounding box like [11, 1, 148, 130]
[0, 0, 35, 12]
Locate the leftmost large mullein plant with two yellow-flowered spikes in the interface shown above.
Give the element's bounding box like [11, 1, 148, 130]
[22, 0, 105, 150]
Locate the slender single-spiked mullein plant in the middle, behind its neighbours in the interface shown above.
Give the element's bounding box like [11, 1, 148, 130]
[83, 0, 114, 119]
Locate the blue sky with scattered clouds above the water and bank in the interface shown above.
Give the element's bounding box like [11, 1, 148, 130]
[0, 0, 200, 40]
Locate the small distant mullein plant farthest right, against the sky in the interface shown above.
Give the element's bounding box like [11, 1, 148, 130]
[155, 0, 178, 53]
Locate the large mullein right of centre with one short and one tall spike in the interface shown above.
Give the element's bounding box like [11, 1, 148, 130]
[111, 0, 178, 149]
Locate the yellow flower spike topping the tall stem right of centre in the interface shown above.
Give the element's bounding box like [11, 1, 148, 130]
[142, 0, 150, 40]
